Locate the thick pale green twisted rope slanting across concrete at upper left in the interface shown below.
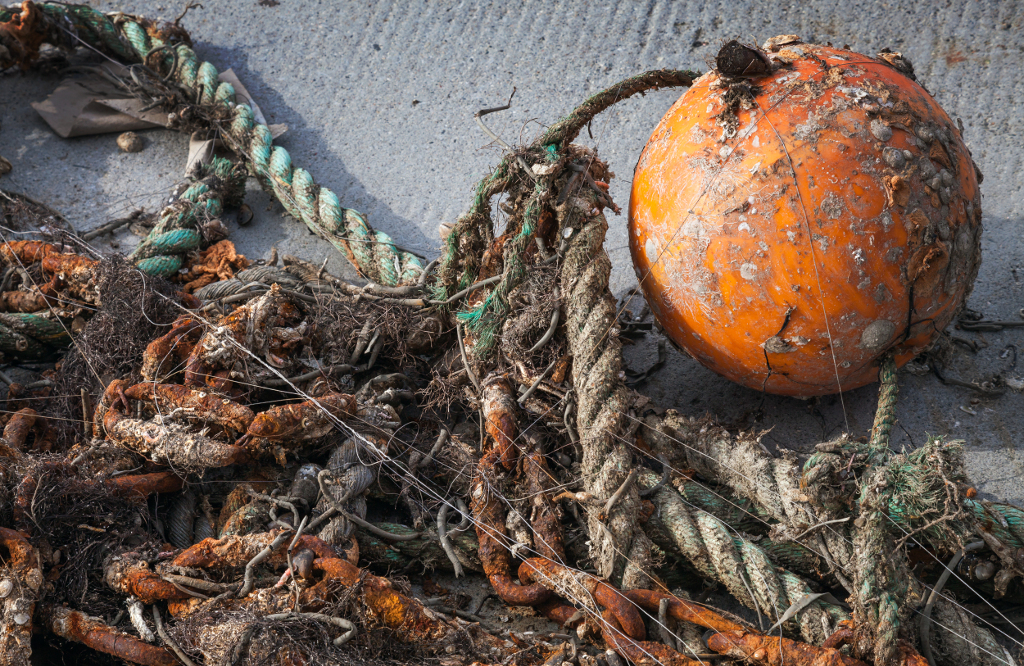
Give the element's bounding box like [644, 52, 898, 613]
[0, 3, 423, 286]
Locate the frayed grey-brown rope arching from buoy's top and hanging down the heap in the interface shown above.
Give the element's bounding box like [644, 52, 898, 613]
[437, 70, 693, 588]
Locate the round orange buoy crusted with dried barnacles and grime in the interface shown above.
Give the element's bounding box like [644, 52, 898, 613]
[629, 36, 981, 397]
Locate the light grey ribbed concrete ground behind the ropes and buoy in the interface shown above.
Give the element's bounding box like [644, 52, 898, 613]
[0, 0, 1024, 504]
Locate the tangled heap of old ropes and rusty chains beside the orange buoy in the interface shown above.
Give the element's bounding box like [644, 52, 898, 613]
[0, 0, 1024, 666]
